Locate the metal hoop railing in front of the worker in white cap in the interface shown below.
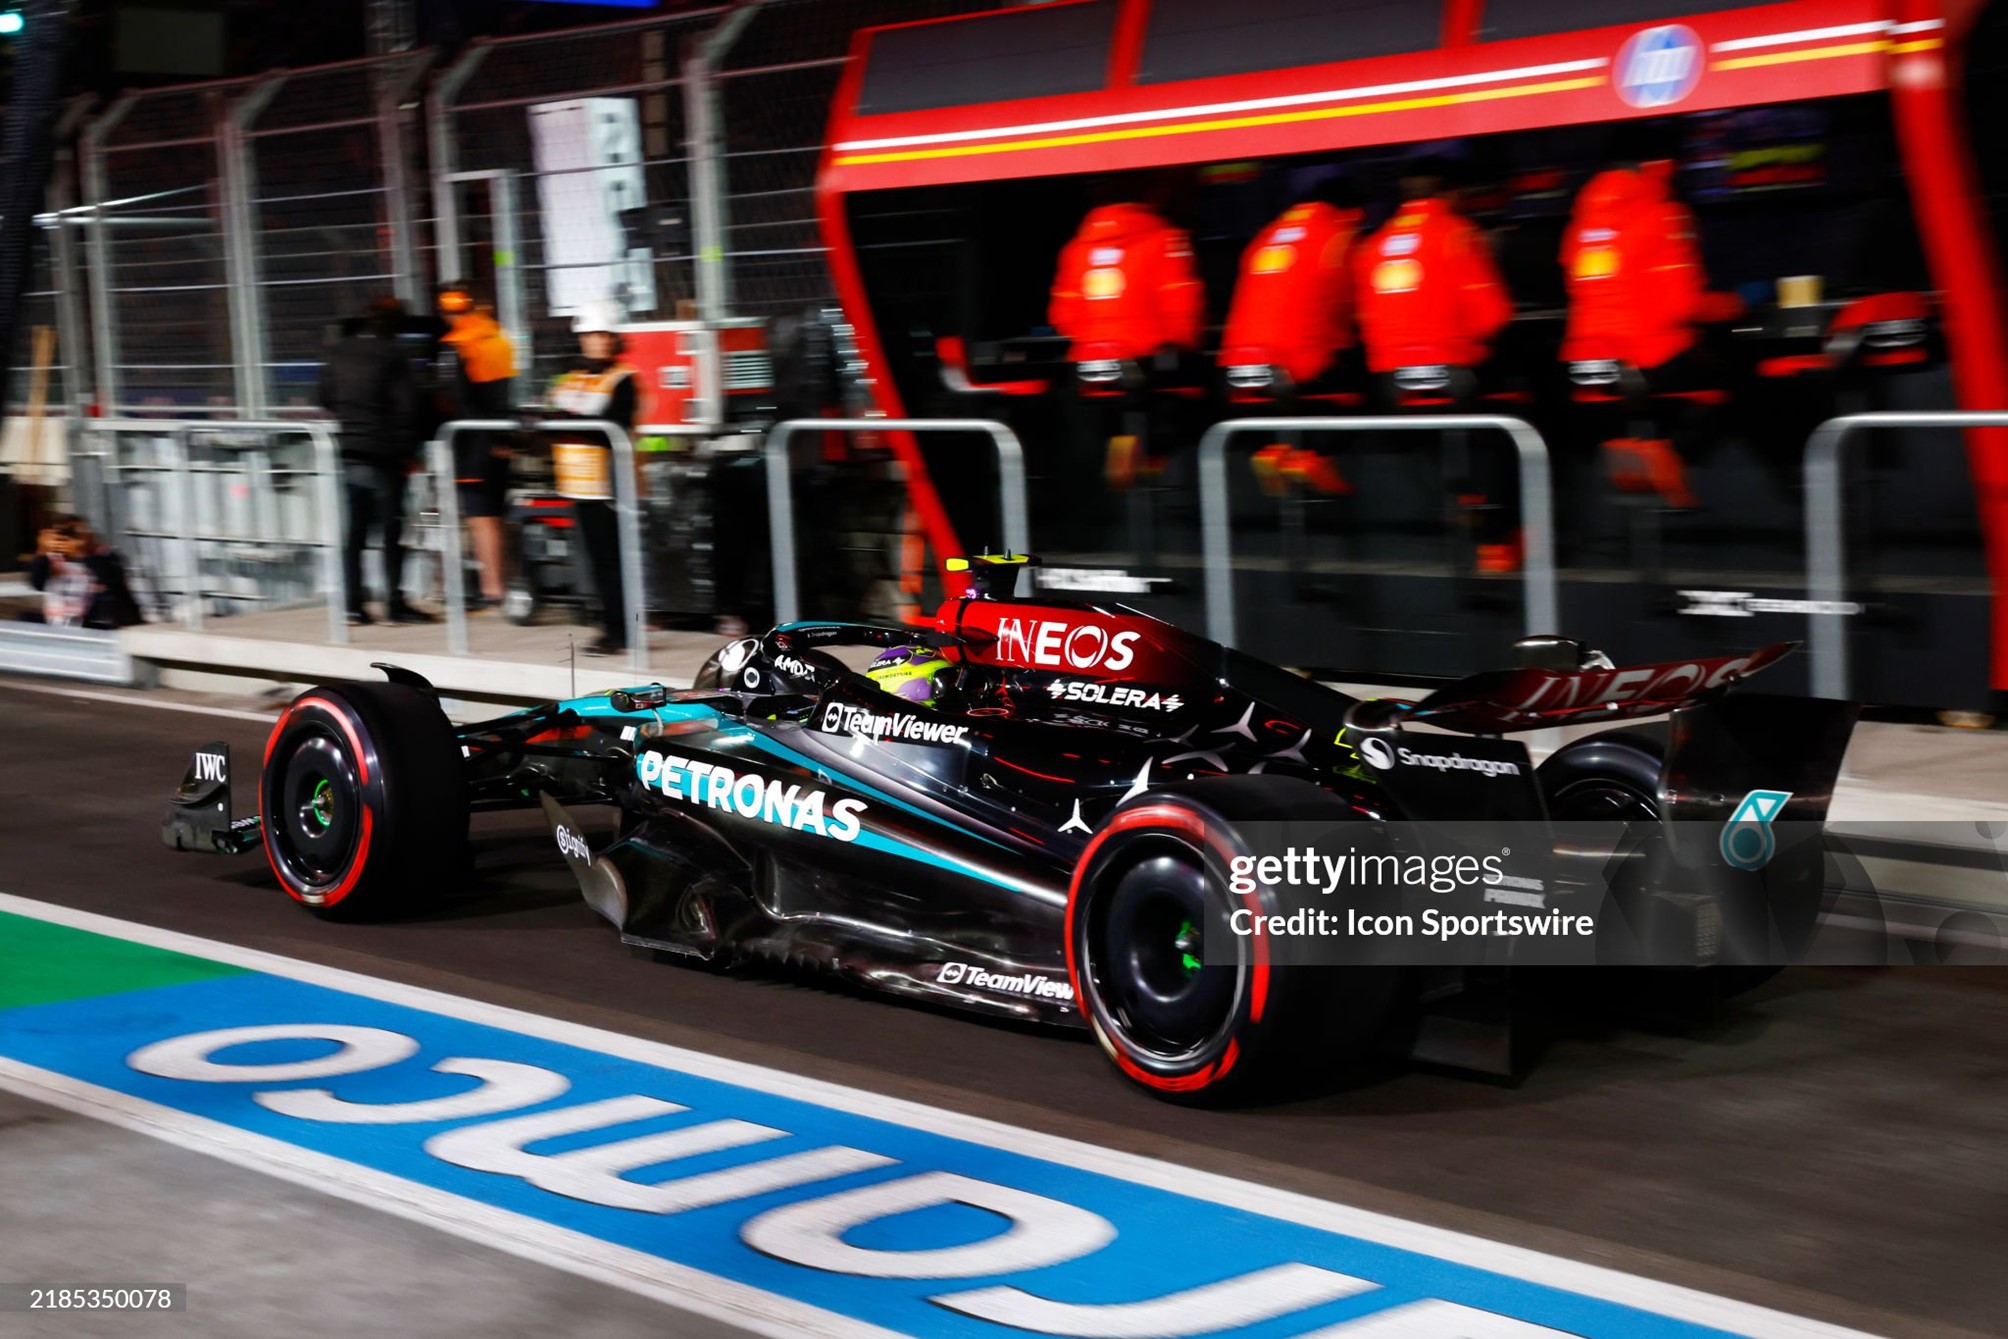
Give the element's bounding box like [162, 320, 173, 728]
[428, 418, 711, 673]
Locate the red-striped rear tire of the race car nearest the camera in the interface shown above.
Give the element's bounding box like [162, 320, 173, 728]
[1066, 777, 1402, 1104]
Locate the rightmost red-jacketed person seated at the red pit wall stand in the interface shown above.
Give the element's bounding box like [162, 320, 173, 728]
[1560, 141, 1739, 508]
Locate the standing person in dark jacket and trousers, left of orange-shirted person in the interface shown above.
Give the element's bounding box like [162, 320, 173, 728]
[321, 297, 432, 624]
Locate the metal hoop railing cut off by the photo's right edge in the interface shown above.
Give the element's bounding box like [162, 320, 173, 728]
[1805, 410, 2008, 699]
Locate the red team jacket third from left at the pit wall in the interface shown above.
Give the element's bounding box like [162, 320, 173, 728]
[1353, 199, 1512, 371]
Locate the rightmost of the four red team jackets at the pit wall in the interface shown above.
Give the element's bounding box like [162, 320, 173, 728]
[1562, 165, 1715, 369]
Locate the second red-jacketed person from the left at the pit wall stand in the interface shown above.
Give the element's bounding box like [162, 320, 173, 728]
[1221, 179, 1361, 494]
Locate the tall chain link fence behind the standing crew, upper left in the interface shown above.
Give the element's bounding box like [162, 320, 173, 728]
[4, 0, 1006, 429]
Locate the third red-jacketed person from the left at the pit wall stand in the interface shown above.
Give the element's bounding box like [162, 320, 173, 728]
[1353, 159, 1520, 572]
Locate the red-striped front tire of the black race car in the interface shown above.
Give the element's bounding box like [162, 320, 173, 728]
[259, 683, 468, 919]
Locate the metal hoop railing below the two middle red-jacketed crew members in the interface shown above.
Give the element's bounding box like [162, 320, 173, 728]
[1199, 414, 1562, 646]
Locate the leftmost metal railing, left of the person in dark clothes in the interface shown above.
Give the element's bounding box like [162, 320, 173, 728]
[78, 418, 349, 644]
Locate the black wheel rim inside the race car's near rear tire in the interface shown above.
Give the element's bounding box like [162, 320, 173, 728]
[1082, 855, 1237, 1068]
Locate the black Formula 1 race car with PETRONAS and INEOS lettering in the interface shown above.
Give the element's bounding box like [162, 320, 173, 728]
[163, 556, 1853, 1100]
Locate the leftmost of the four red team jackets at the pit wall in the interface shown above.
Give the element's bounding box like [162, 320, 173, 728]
[1048, 205, 1207, 361]
